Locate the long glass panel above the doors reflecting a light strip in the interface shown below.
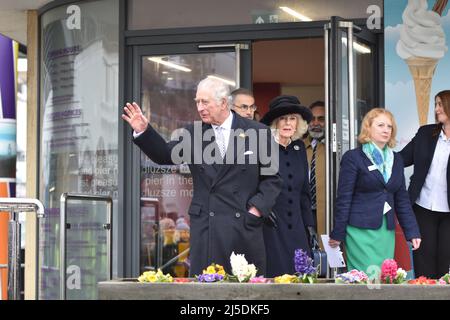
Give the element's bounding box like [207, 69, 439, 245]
[127, 0, 383, 30]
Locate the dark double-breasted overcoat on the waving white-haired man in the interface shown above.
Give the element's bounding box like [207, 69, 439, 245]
[134, 112, 282, 276]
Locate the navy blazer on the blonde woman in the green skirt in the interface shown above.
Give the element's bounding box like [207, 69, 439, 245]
[330, 147, 420, 241]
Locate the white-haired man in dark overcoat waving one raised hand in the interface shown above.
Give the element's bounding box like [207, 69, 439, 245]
[122, 78, 281, 276]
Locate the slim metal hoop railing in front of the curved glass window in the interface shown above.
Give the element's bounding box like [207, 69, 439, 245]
[60, 193, 112, 300]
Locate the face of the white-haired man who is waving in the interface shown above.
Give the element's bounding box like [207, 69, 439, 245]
[195, 88, 228, 125]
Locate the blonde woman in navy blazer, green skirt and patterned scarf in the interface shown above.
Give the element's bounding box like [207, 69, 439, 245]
[329, 108, 421, 271]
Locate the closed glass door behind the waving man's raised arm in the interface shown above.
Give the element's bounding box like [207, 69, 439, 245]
[132, 43, 250, 277]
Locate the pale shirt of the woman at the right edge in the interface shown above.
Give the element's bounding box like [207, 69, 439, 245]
[416, 131, 450, 212]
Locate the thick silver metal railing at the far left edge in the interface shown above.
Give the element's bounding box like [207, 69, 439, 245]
[0, 198, 44, 300]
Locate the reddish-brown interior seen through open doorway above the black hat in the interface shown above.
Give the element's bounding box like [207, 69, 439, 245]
[252, 37, 325, 116]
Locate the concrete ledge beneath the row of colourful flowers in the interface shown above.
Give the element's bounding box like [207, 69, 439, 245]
[98, 279, 450, 300]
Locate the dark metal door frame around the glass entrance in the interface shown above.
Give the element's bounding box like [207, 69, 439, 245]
[117, 19, 384, 277]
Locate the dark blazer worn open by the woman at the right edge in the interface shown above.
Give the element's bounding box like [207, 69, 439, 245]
[400, 124, 450, 206]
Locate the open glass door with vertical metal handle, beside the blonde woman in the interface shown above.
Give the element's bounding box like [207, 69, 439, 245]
[324, 17, 379, 268]
